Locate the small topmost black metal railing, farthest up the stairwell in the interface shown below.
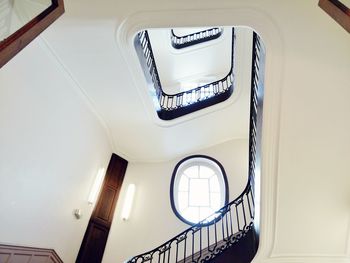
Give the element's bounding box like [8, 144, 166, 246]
[171, 27, 223, 49]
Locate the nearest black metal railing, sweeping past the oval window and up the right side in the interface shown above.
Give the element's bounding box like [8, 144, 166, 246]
[127, 33, 264, 263]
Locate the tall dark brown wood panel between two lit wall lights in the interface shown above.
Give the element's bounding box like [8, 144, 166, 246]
[76, 154, 128, 263]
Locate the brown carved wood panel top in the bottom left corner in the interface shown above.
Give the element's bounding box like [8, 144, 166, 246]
[0, 244, 63, 263]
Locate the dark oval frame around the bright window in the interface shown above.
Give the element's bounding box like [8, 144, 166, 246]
[170, 154, 229, 226]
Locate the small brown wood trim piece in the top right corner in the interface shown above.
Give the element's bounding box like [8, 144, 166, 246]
[318, 0, 350, 33]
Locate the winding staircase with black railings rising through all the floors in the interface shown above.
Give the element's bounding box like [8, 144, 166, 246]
[126, 28, 265, 263]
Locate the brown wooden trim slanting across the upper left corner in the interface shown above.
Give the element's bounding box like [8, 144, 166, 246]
[0, 0, 64, 68]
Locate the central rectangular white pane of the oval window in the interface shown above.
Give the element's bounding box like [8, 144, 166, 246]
[189, 179, 210, 206]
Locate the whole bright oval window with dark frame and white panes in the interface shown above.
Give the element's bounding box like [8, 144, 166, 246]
[170, 155, 228, 225]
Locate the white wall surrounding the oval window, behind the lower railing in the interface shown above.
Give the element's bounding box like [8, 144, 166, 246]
[103, 139, 248, 263]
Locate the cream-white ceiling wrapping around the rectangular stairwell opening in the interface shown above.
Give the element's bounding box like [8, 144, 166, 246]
[32, 0, 350, 263]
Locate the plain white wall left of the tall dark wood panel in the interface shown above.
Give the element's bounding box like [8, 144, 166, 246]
[0, 36, 112, 262]
